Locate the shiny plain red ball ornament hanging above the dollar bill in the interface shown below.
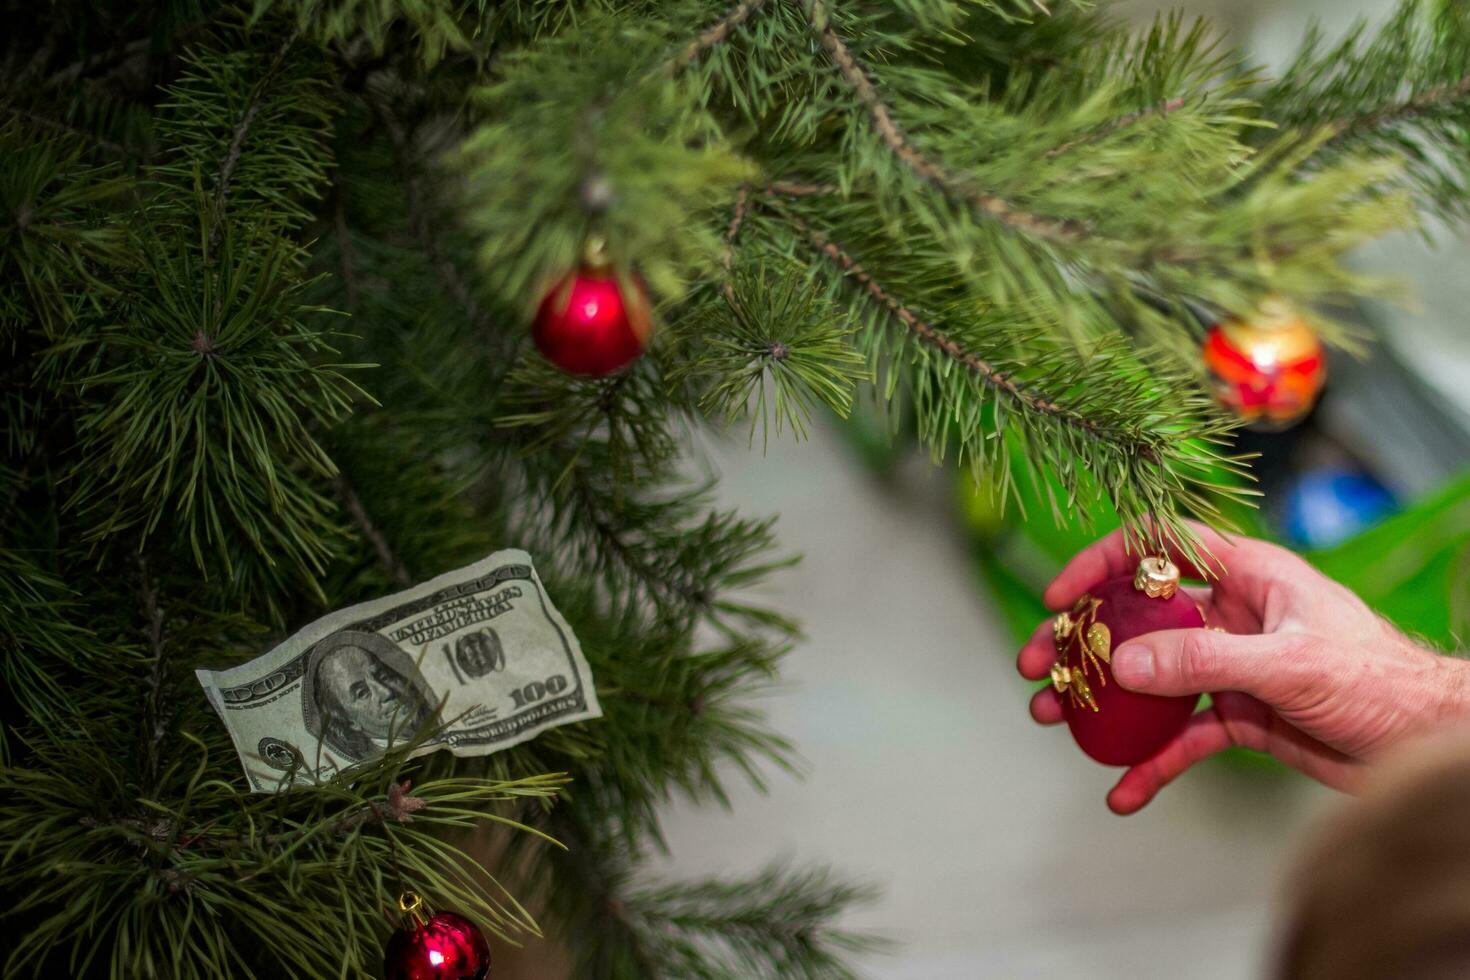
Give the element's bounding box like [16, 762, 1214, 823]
[531, 239, 653, 378]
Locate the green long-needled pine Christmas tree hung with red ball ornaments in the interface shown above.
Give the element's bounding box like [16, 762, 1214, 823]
[0, 0, 1470, 977]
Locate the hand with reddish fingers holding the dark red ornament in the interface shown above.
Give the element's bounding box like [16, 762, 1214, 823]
[1017, 525, 1470, 814]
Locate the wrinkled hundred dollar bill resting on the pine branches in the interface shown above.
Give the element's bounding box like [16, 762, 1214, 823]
[197, 551, 603, 792]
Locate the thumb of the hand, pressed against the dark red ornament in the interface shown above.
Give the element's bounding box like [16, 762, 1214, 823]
[1113, 629, 1330, 707]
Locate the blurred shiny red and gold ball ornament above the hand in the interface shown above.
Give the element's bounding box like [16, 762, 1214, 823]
[1204, 300, 1327, 430]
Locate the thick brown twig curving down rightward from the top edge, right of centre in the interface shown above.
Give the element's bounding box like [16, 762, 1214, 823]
[806, 0, 1083, 242]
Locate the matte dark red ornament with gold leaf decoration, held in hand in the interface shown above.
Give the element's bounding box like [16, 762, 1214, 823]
[1051, 558, 1204, 765]
